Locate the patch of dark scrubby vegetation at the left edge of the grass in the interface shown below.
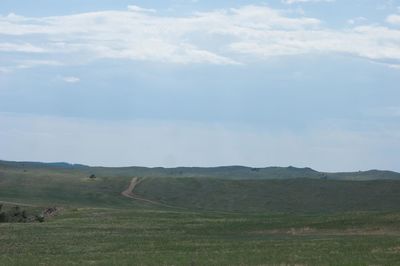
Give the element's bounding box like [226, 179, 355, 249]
[0, 204, 59, 223]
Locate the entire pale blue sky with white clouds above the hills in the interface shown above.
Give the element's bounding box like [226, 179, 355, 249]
[0, 0, 400, 171]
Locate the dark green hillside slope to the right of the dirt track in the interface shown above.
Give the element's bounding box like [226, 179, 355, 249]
[135, 178, 400, 212]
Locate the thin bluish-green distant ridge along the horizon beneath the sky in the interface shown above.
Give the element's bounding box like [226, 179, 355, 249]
[0, 160, 400, 181]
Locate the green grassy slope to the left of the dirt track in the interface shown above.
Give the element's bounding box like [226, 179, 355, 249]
[0, 166, 135, 207]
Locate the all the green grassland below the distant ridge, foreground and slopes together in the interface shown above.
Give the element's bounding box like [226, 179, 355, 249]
[0, 161, 400, 265]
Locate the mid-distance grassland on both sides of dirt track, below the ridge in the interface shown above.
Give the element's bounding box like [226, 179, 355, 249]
[0, 162, 400, 212]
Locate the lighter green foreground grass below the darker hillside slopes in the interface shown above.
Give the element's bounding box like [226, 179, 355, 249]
[0, 208, 400, 265]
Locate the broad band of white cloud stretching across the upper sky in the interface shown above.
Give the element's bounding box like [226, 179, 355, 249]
[0, 5, 400, 64]
